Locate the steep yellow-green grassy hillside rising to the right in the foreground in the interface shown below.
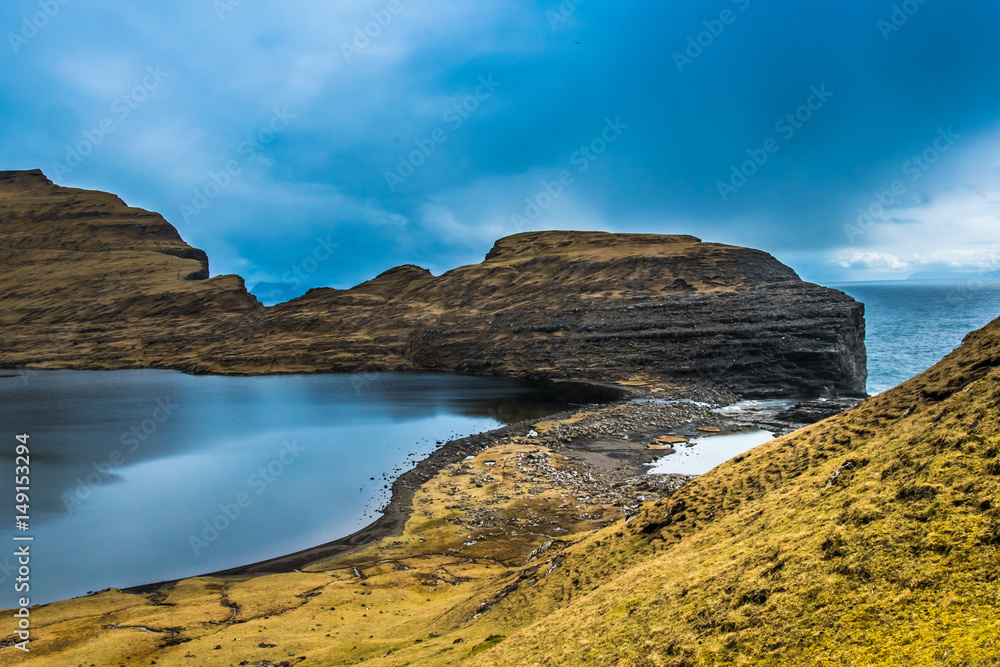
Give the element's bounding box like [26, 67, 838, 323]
[470, 320, 1000, 665]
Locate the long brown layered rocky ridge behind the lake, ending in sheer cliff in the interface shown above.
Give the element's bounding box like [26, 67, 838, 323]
[0, 171, 866, 395]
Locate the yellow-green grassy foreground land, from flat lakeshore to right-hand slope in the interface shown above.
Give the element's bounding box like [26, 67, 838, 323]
[0, 264, 1000, 667]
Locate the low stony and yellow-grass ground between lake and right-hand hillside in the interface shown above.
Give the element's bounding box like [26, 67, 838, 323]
[0, 380, 868, 665]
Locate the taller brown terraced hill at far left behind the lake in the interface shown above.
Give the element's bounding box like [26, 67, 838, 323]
[0, 170, 263, 368]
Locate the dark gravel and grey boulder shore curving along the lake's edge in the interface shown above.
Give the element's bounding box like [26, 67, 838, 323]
[127, 389, 858, 593]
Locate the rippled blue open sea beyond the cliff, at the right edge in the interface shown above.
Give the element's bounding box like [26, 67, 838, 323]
[832, 279, 1000, 394]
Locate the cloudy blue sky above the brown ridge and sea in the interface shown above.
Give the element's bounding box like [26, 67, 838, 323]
[0, 0, 1000, 302]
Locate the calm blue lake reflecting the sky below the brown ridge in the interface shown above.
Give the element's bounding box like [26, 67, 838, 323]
[0, 370, 588, 608]
